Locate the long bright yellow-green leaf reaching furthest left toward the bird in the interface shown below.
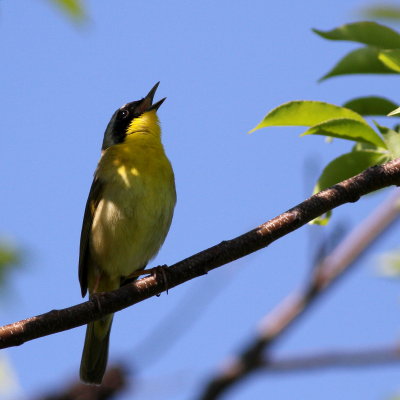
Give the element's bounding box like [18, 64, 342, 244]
[249, 100, 366, 133]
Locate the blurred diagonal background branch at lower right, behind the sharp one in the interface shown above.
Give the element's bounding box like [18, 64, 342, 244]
[199, 190, 400, 400]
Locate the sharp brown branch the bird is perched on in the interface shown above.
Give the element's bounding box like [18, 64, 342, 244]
[0, 158, 400, 348]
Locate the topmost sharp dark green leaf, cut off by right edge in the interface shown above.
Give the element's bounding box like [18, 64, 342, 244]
[313, 21, 400, 49]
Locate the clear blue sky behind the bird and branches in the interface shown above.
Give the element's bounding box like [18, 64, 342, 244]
[0, 0, 400, 400]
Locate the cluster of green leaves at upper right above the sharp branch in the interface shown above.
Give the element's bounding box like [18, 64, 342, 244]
[250, 22, 400, 224]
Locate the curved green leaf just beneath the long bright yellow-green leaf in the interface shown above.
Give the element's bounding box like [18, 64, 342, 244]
[301, 118, 386, 148]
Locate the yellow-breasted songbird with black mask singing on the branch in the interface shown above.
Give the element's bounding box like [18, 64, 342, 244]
[79, 82, 176, 385]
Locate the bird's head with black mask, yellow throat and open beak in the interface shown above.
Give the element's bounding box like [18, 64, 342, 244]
[102, 82, 166, 151]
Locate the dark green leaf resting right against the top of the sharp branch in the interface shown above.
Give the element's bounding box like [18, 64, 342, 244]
[313, 151, 388, 193]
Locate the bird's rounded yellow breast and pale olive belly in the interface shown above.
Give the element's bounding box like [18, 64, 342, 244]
[91, 130, 176, 277]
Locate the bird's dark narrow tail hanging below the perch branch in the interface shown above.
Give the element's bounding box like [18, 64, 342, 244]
[79, 314, 114, 385]
